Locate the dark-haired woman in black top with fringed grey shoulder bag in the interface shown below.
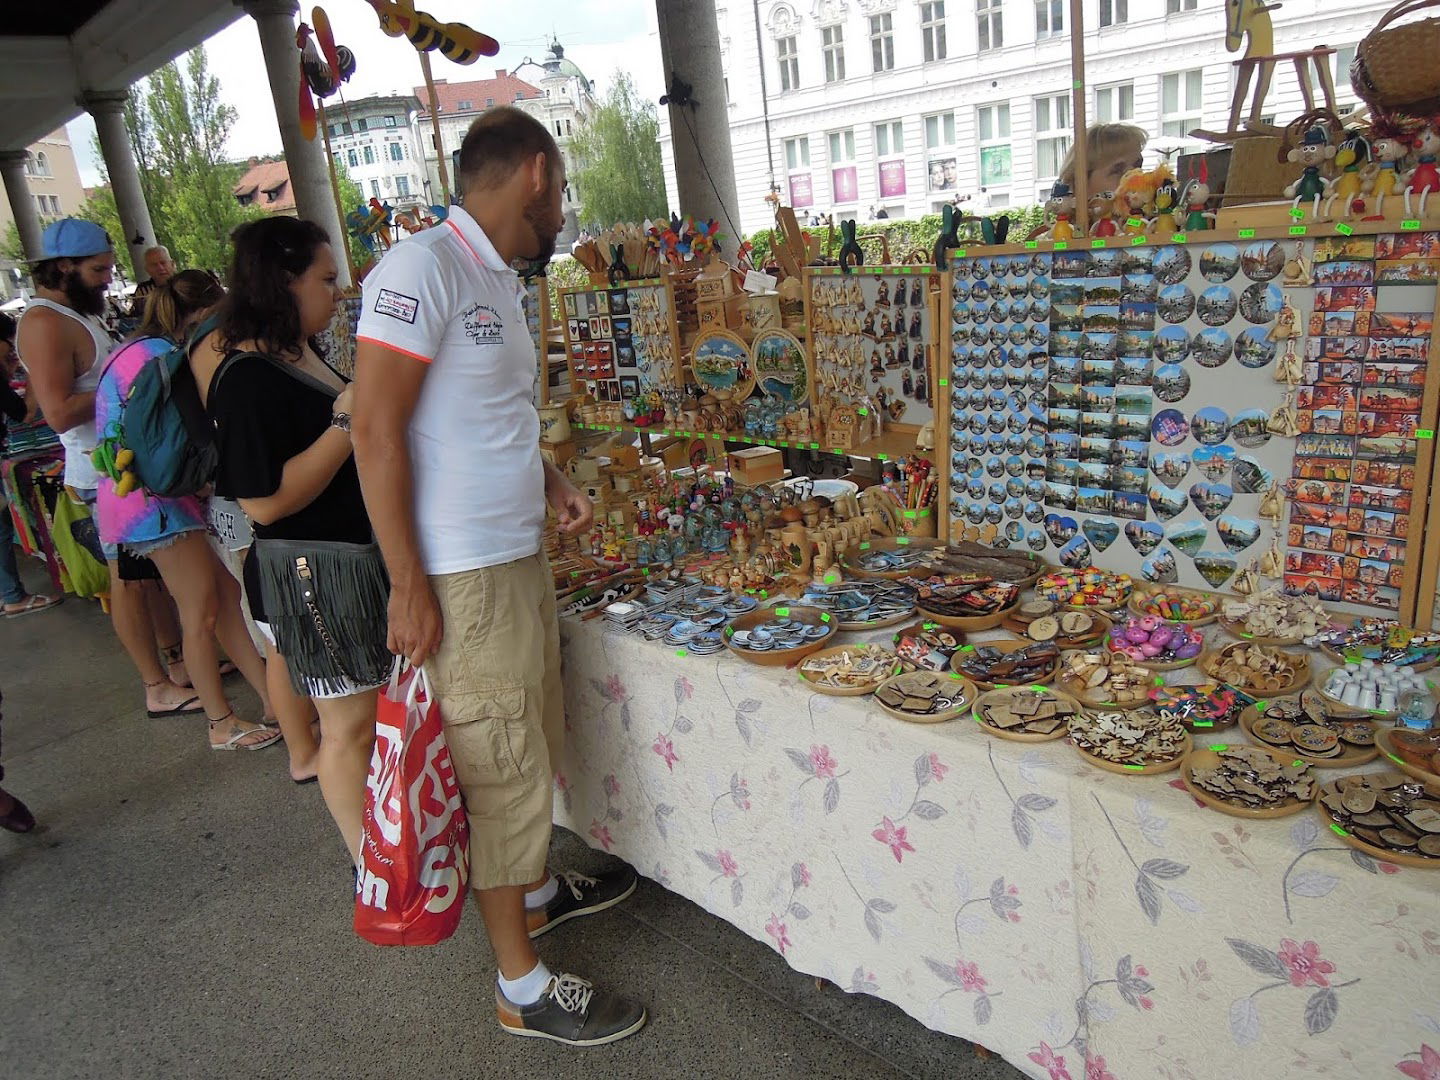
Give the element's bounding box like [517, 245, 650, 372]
[190, 217, 392, 858]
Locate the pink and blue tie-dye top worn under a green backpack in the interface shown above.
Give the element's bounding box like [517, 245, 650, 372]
[95, 337, 206, 546]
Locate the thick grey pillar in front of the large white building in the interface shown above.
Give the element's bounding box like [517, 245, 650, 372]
[655, 0, 744, 249]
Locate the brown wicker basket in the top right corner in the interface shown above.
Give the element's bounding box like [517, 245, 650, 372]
[1349, 0, 1440, 114]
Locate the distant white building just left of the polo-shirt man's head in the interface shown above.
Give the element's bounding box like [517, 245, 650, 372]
[325, 94, 429, 213]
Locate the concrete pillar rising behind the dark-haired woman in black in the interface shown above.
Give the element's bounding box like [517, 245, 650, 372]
[242, 0, 350, 285]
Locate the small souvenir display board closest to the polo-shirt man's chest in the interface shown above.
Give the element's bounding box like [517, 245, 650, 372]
[560, 279, 678, 402]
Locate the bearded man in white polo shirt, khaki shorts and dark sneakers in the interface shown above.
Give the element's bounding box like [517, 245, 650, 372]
[353, 107, 645, 1045]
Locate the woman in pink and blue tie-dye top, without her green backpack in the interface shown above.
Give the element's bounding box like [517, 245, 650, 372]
[95, 271, 281, 750]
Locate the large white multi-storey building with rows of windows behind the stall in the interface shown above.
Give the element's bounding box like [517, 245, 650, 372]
[661, 0, 1391, 233]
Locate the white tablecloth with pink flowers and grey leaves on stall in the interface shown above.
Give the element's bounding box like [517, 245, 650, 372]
[556, 622, 1440, 1080]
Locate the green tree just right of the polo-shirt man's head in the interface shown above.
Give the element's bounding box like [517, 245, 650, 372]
[570, 72, 667, 226]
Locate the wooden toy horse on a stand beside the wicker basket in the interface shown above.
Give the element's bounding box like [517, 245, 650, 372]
[1192, 0, 1335, 143]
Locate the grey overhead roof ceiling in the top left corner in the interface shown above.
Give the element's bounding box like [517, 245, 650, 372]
[0, 0, 243, 150]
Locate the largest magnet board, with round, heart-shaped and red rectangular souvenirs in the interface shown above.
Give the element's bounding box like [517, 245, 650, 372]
[949, 238, 1434, 609]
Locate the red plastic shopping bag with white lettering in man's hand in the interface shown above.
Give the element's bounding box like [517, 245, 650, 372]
[356, 661, 469, 945]
